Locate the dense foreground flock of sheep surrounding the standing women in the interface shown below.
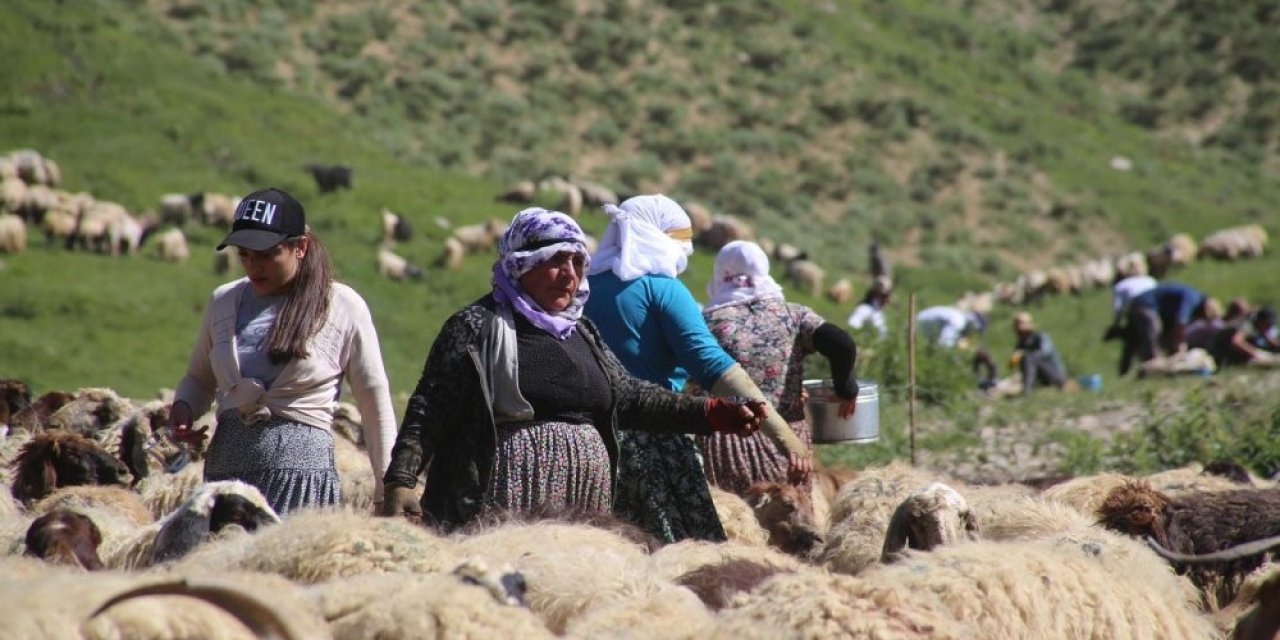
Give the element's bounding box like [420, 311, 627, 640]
[0, 380, 1280, 639]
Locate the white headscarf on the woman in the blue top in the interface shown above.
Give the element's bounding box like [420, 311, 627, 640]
[586, 195, 694, 282]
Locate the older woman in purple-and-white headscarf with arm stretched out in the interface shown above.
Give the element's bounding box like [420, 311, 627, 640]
[383, 207, 763, 529]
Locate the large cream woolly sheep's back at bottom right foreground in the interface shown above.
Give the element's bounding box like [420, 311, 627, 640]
[722, 531, 1216, 639]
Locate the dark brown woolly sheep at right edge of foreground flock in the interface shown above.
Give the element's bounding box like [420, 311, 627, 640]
[1097, 480, 1280, 603]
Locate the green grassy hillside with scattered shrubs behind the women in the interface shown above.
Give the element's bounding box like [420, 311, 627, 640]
[0, 0, 1280, 463]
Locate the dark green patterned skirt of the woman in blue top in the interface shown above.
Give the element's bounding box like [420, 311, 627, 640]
[613, 431, 727, 543]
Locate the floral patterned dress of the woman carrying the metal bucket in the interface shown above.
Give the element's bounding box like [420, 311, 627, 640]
[698, 297, 826, 494]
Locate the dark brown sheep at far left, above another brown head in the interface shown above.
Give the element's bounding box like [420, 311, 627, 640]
[13, 433, 129, 504]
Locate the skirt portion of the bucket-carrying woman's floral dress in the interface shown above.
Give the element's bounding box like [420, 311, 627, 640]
[698, 420, 813, 495]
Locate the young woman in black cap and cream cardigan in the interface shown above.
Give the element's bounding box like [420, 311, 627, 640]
[169, 188, 396, 515]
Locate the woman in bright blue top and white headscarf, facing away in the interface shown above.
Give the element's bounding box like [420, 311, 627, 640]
[586, 195, 810, 543]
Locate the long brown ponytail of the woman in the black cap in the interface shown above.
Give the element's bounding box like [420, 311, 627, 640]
[266, 227, 333, 365]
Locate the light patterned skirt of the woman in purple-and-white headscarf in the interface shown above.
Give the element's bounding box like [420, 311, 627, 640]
[488, 421, 613, 513]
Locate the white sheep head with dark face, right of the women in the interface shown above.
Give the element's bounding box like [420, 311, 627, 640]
[881, 483, 979, 563]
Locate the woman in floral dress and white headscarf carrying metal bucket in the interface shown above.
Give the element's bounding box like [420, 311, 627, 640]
[698, 241, 858, 494]
